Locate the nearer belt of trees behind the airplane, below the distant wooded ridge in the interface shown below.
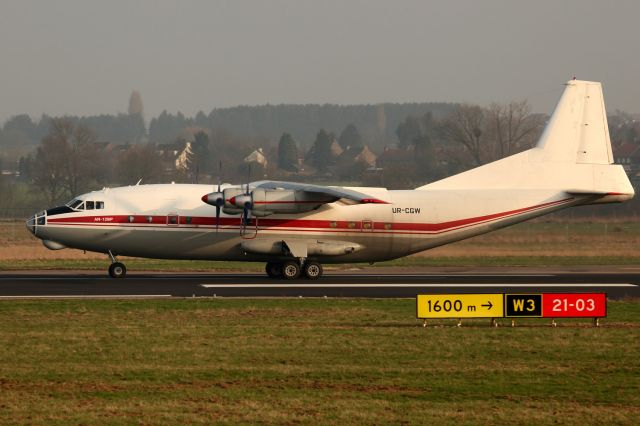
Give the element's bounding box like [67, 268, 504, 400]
[0, 96, 640, 213]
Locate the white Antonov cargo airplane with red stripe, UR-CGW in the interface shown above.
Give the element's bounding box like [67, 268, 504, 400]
[27, 80, 634, 279]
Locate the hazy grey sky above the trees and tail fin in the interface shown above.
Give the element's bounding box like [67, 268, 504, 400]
[0, 0, 640, 123]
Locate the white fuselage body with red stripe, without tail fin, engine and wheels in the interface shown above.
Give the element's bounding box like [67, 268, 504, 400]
[27, 184, 596, 263]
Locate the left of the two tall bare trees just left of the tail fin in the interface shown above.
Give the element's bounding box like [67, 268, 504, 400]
[442, 104, 485, 166]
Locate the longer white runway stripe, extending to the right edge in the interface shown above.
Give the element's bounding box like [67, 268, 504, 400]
[200, 283, 637, 289]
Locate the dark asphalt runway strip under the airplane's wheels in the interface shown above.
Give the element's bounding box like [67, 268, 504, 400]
[0, 268, 640, 299]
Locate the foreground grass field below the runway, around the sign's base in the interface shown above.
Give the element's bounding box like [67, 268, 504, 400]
[0, 299, 640, 424]
